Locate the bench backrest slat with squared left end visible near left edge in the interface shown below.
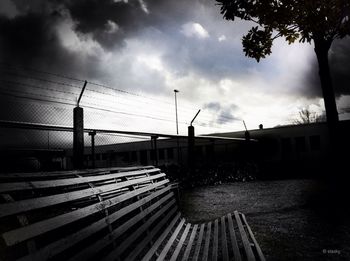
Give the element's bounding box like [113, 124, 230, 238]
[2, 180, 170, 246]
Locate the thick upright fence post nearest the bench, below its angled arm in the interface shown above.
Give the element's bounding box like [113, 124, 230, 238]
[73, 107, 84, 169]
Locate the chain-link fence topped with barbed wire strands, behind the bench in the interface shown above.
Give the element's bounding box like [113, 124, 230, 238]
[0, 64, 258, 183]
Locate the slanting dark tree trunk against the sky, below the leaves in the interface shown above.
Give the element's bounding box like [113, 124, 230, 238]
[314, 39, 339, 144]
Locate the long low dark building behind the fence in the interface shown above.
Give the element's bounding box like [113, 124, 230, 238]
[67, 121, 350, 177]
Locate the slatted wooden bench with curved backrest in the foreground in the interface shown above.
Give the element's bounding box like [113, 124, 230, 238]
[0, 166, 264, 260]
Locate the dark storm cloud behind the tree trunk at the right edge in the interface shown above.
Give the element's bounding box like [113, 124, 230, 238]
[304, 37, 350, 98]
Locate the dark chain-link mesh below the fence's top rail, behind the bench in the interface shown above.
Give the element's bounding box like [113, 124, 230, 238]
[0, 120, 256, 184]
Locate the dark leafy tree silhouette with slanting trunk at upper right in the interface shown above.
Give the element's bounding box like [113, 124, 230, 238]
[216, 0, 350, 142]
